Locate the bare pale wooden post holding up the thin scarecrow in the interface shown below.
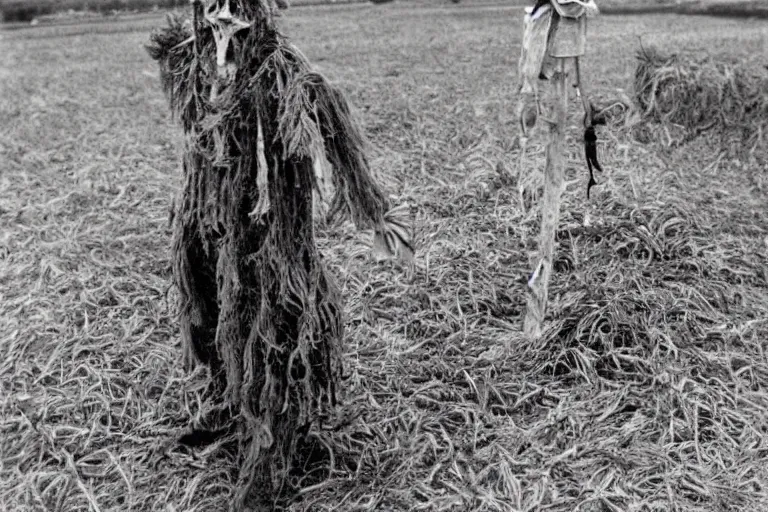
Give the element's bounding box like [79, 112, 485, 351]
[523, 59, 568, 339]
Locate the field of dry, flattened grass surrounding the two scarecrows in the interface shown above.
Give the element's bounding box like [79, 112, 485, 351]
[0, 4, 768, 512]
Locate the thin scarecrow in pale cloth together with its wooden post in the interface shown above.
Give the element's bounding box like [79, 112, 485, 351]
[517, 0, 604, 338]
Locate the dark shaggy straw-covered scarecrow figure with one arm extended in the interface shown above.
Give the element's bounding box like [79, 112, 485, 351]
[148, 0, 412, 510]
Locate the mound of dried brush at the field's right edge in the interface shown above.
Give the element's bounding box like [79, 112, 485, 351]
[635, 48, 768, 148]
